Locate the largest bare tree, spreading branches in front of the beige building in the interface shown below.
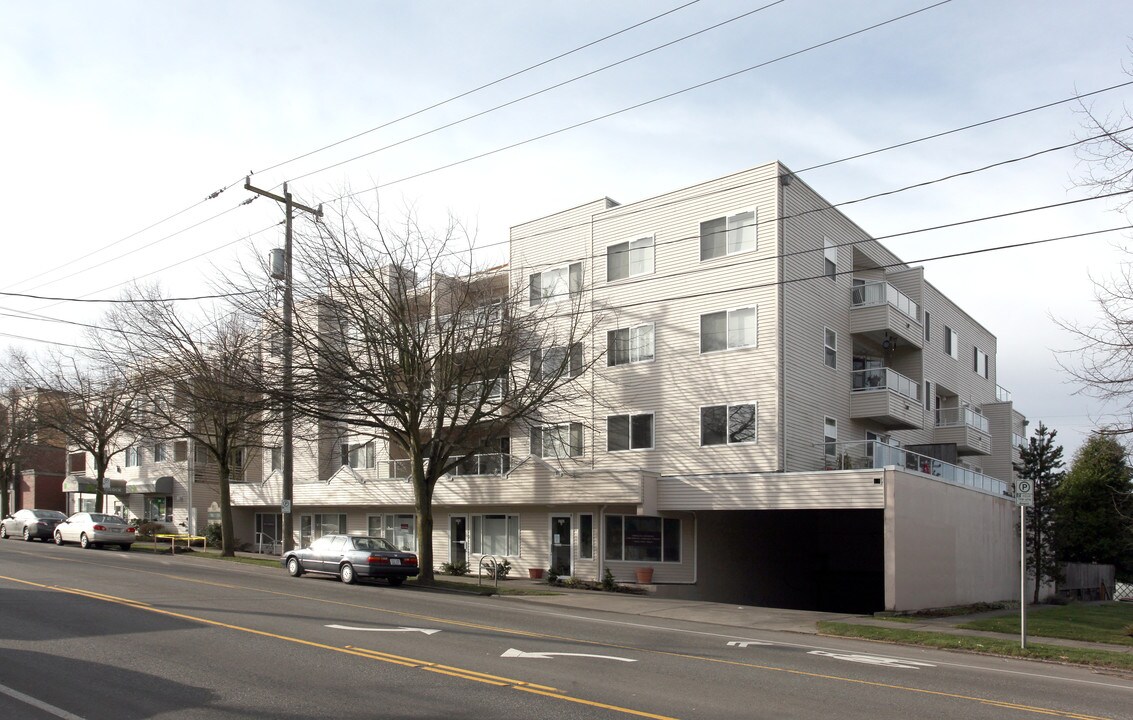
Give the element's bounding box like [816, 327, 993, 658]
[232, 199, 596, 582]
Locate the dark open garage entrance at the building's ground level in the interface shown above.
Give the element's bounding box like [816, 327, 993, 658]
[679, 509, 885, 612]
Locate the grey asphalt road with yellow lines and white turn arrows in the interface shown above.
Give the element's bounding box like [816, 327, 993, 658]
[0, 540, 1133, 720]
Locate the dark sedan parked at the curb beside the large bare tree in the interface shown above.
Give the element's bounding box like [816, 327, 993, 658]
[281, 535, 419, 585]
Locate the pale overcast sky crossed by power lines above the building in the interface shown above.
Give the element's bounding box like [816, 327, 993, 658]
[0, 0, 1133, 459]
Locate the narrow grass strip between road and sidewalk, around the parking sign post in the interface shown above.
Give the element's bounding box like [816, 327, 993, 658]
[818, 620, 1133, 670]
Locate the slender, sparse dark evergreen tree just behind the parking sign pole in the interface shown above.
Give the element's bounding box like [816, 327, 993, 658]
[1015, 423, 1065, 602]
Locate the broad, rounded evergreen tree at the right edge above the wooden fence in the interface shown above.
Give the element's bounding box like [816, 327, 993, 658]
[1055, 435, 1133, 577]
